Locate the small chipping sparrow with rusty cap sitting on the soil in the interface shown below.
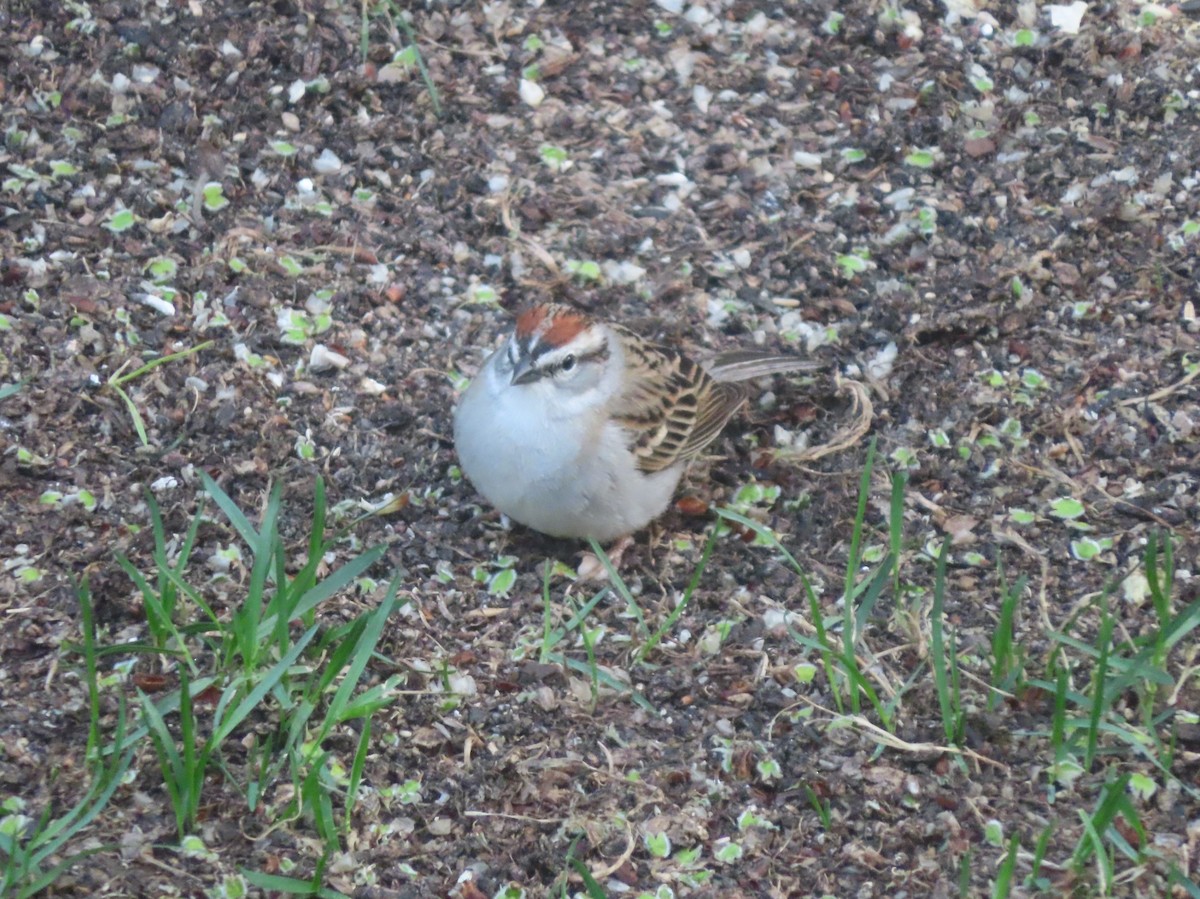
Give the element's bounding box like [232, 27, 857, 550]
[454, 304, 815, 541]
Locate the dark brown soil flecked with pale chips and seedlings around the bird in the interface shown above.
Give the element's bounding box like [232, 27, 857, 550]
[0, 0, 1200, 899]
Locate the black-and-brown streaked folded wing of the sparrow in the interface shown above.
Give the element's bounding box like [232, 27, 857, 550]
[614, 328, 745, 473]
